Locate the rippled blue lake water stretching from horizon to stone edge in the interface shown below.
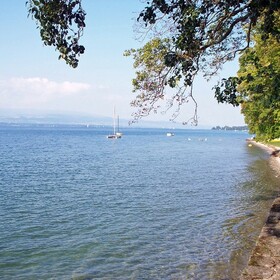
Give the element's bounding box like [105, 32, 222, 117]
[0, 126, 279, 280]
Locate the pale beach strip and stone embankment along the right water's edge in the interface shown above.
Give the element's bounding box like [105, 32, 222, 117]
[239, 140, 280, 280]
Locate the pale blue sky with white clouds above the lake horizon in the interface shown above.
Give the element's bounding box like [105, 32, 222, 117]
[0, 0, 244, 128]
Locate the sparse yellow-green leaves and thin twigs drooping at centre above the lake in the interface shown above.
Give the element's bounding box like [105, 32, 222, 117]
[124, 38, 197, 123]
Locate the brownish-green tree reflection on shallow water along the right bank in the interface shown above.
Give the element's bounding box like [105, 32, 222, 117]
[222, 153, 280, 279]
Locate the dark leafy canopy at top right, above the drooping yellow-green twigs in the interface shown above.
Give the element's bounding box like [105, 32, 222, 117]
[138, 0, 280, 62]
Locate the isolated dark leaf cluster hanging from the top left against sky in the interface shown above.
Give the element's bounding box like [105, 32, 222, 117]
[26, 0, 85, 68]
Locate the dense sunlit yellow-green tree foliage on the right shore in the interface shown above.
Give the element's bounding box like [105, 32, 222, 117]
[237, 35, 280, 140]
